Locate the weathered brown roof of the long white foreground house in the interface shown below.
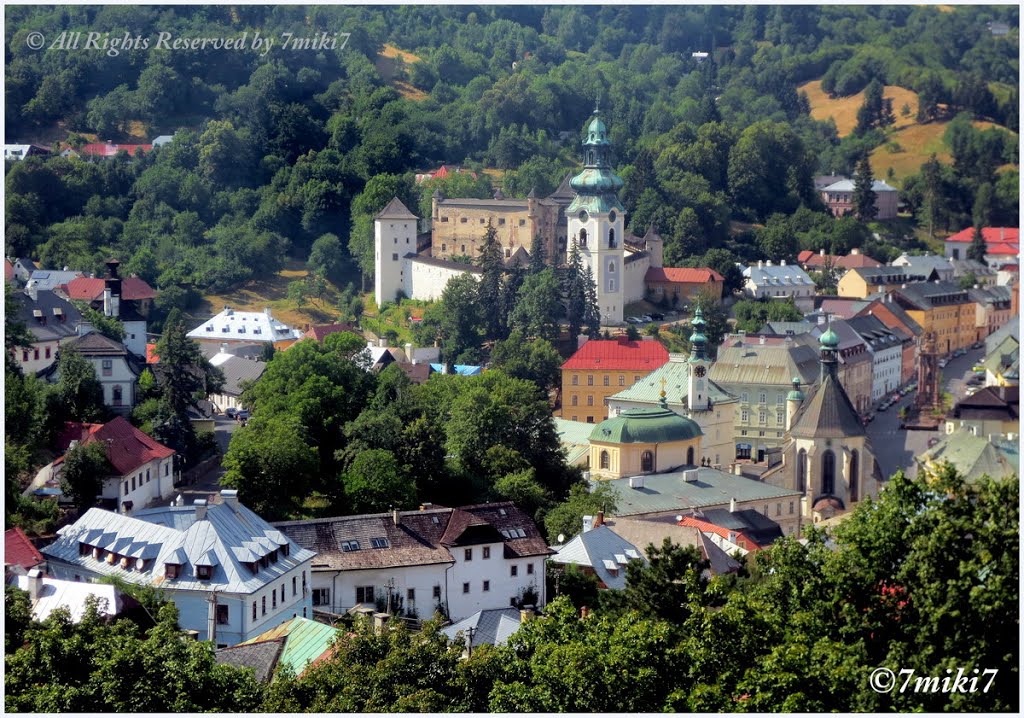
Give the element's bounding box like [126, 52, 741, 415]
[273, 502, 551, 571]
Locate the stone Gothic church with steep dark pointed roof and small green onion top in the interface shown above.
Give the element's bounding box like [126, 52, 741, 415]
[761, 327, 882, 523]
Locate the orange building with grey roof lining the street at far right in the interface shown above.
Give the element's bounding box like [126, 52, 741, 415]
[893, 282, 977, 354]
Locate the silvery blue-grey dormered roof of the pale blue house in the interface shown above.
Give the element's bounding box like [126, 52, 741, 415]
[42, 495, 315, 593]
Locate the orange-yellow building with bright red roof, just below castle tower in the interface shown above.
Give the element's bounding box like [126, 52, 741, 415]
[561, 337, 669, 424]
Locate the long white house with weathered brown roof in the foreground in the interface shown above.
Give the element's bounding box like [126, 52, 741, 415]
[274, 502, 551, 621]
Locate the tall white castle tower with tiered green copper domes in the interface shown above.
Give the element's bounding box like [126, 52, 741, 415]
[565, 109, 626, 325]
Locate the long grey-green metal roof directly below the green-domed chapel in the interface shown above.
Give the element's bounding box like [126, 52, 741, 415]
[605, 466, 801, 516]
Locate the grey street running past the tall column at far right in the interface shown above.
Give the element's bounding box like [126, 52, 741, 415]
[867, 348, 984, 479]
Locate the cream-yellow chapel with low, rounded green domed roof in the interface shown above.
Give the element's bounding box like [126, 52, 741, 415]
[590, 396, 701, 478]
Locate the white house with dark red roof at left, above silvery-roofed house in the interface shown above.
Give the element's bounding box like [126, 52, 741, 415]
[50, 417, 175, 515]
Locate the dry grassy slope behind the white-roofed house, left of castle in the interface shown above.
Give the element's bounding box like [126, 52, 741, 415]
[194, 261, 348, 329]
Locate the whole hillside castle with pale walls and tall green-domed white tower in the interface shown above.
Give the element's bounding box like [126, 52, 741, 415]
[374, 109, 692, 327]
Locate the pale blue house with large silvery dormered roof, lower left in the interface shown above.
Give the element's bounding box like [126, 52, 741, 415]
[43, 490, 314, 646]
